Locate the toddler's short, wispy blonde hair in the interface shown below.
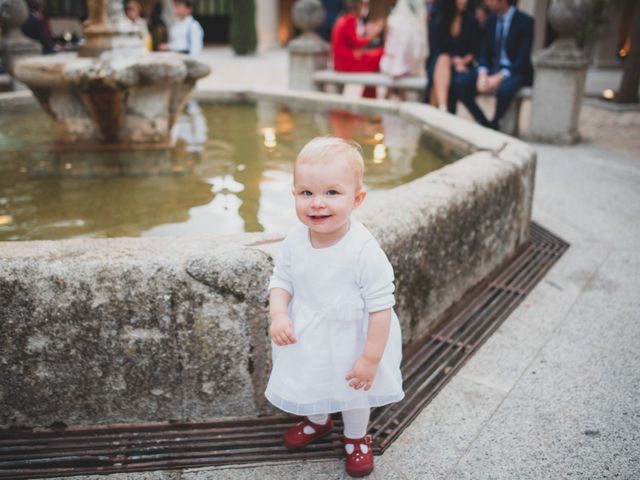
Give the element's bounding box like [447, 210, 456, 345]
[293, 135, 364, 191]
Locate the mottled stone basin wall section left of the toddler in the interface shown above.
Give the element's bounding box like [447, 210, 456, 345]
[0, 235, 280, 427]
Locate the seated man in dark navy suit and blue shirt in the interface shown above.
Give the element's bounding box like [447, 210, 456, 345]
[454, 0, 533, 130]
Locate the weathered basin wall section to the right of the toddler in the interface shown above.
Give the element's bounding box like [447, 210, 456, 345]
[359, 152, 528, 343]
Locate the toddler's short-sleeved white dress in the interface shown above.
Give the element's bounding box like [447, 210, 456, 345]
[265, 220, 404, 415]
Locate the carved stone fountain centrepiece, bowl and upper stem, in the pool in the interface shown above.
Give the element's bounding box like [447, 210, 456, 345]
[10, 0, 210, 148]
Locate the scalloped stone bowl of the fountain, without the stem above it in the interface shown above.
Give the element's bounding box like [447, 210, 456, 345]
[16, 53, 209, 148]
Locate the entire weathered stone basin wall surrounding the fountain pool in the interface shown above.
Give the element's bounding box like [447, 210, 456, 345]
[0, 93, 535, 428]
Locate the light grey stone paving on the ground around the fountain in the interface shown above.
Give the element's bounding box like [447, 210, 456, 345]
[56, 49, 640, 480]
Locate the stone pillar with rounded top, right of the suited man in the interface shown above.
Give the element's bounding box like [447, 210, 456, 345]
[529, 0, 591, 144]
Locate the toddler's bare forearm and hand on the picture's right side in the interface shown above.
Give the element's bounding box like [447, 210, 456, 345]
[346, 308, 391, 391]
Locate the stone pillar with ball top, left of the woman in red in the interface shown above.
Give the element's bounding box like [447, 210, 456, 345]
[289, 0, 331, 90]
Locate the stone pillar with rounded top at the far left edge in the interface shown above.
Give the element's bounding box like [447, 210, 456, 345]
[0, 0, 42, 89]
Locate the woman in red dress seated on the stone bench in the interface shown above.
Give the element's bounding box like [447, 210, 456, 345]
[331, 0, 384, 98]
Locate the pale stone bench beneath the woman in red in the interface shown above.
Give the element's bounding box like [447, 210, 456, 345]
[313, 70, 427, 102]
